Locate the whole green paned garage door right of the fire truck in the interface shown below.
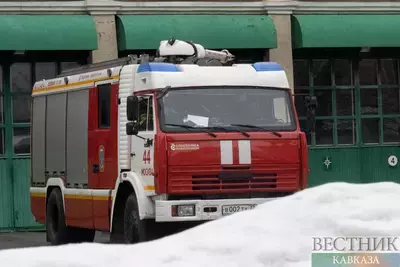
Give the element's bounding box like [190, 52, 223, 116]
[294, 51, 400, 186]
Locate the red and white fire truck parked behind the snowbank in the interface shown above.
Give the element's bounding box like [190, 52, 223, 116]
[30, 39, 308, 244]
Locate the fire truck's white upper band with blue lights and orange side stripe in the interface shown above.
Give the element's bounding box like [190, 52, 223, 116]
[32, 62, 289, 96]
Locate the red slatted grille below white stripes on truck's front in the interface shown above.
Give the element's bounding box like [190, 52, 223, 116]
[168, 166, 299, 193]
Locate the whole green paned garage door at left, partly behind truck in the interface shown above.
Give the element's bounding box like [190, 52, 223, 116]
[0, 53, 86, 231]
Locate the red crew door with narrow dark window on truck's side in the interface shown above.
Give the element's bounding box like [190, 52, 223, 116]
[88, 81, 118, 230]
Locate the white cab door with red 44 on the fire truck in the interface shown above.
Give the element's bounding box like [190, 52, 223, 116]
[131, 96, 155, 192]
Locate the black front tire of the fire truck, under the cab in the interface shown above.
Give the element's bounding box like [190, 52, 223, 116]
[124, 193, 156, 244]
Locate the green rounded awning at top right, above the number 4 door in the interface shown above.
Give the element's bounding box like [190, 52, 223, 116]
[292, 14, 400, 48]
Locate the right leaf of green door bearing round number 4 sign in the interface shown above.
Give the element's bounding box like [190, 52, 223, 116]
[355, 57, 400, 182]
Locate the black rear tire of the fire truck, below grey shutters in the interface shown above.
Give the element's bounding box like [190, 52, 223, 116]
[46, 188, 70, 245]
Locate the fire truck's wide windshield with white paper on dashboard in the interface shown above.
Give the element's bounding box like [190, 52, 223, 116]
[159, 87, 296, 132]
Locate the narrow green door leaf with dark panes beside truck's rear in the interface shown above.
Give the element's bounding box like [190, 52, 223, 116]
[6, 62, 37, 228]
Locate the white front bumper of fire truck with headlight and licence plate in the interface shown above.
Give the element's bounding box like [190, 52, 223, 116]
[155, 198, 276, 222]
